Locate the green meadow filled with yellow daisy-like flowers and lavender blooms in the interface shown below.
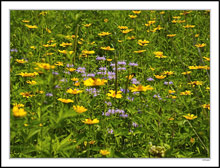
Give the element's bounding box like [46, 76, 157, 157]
[10, 10, 210, 158]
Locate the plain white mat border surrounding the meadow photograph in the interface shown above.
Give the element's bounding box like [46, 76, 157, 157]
[1, 1, 219, 167]
